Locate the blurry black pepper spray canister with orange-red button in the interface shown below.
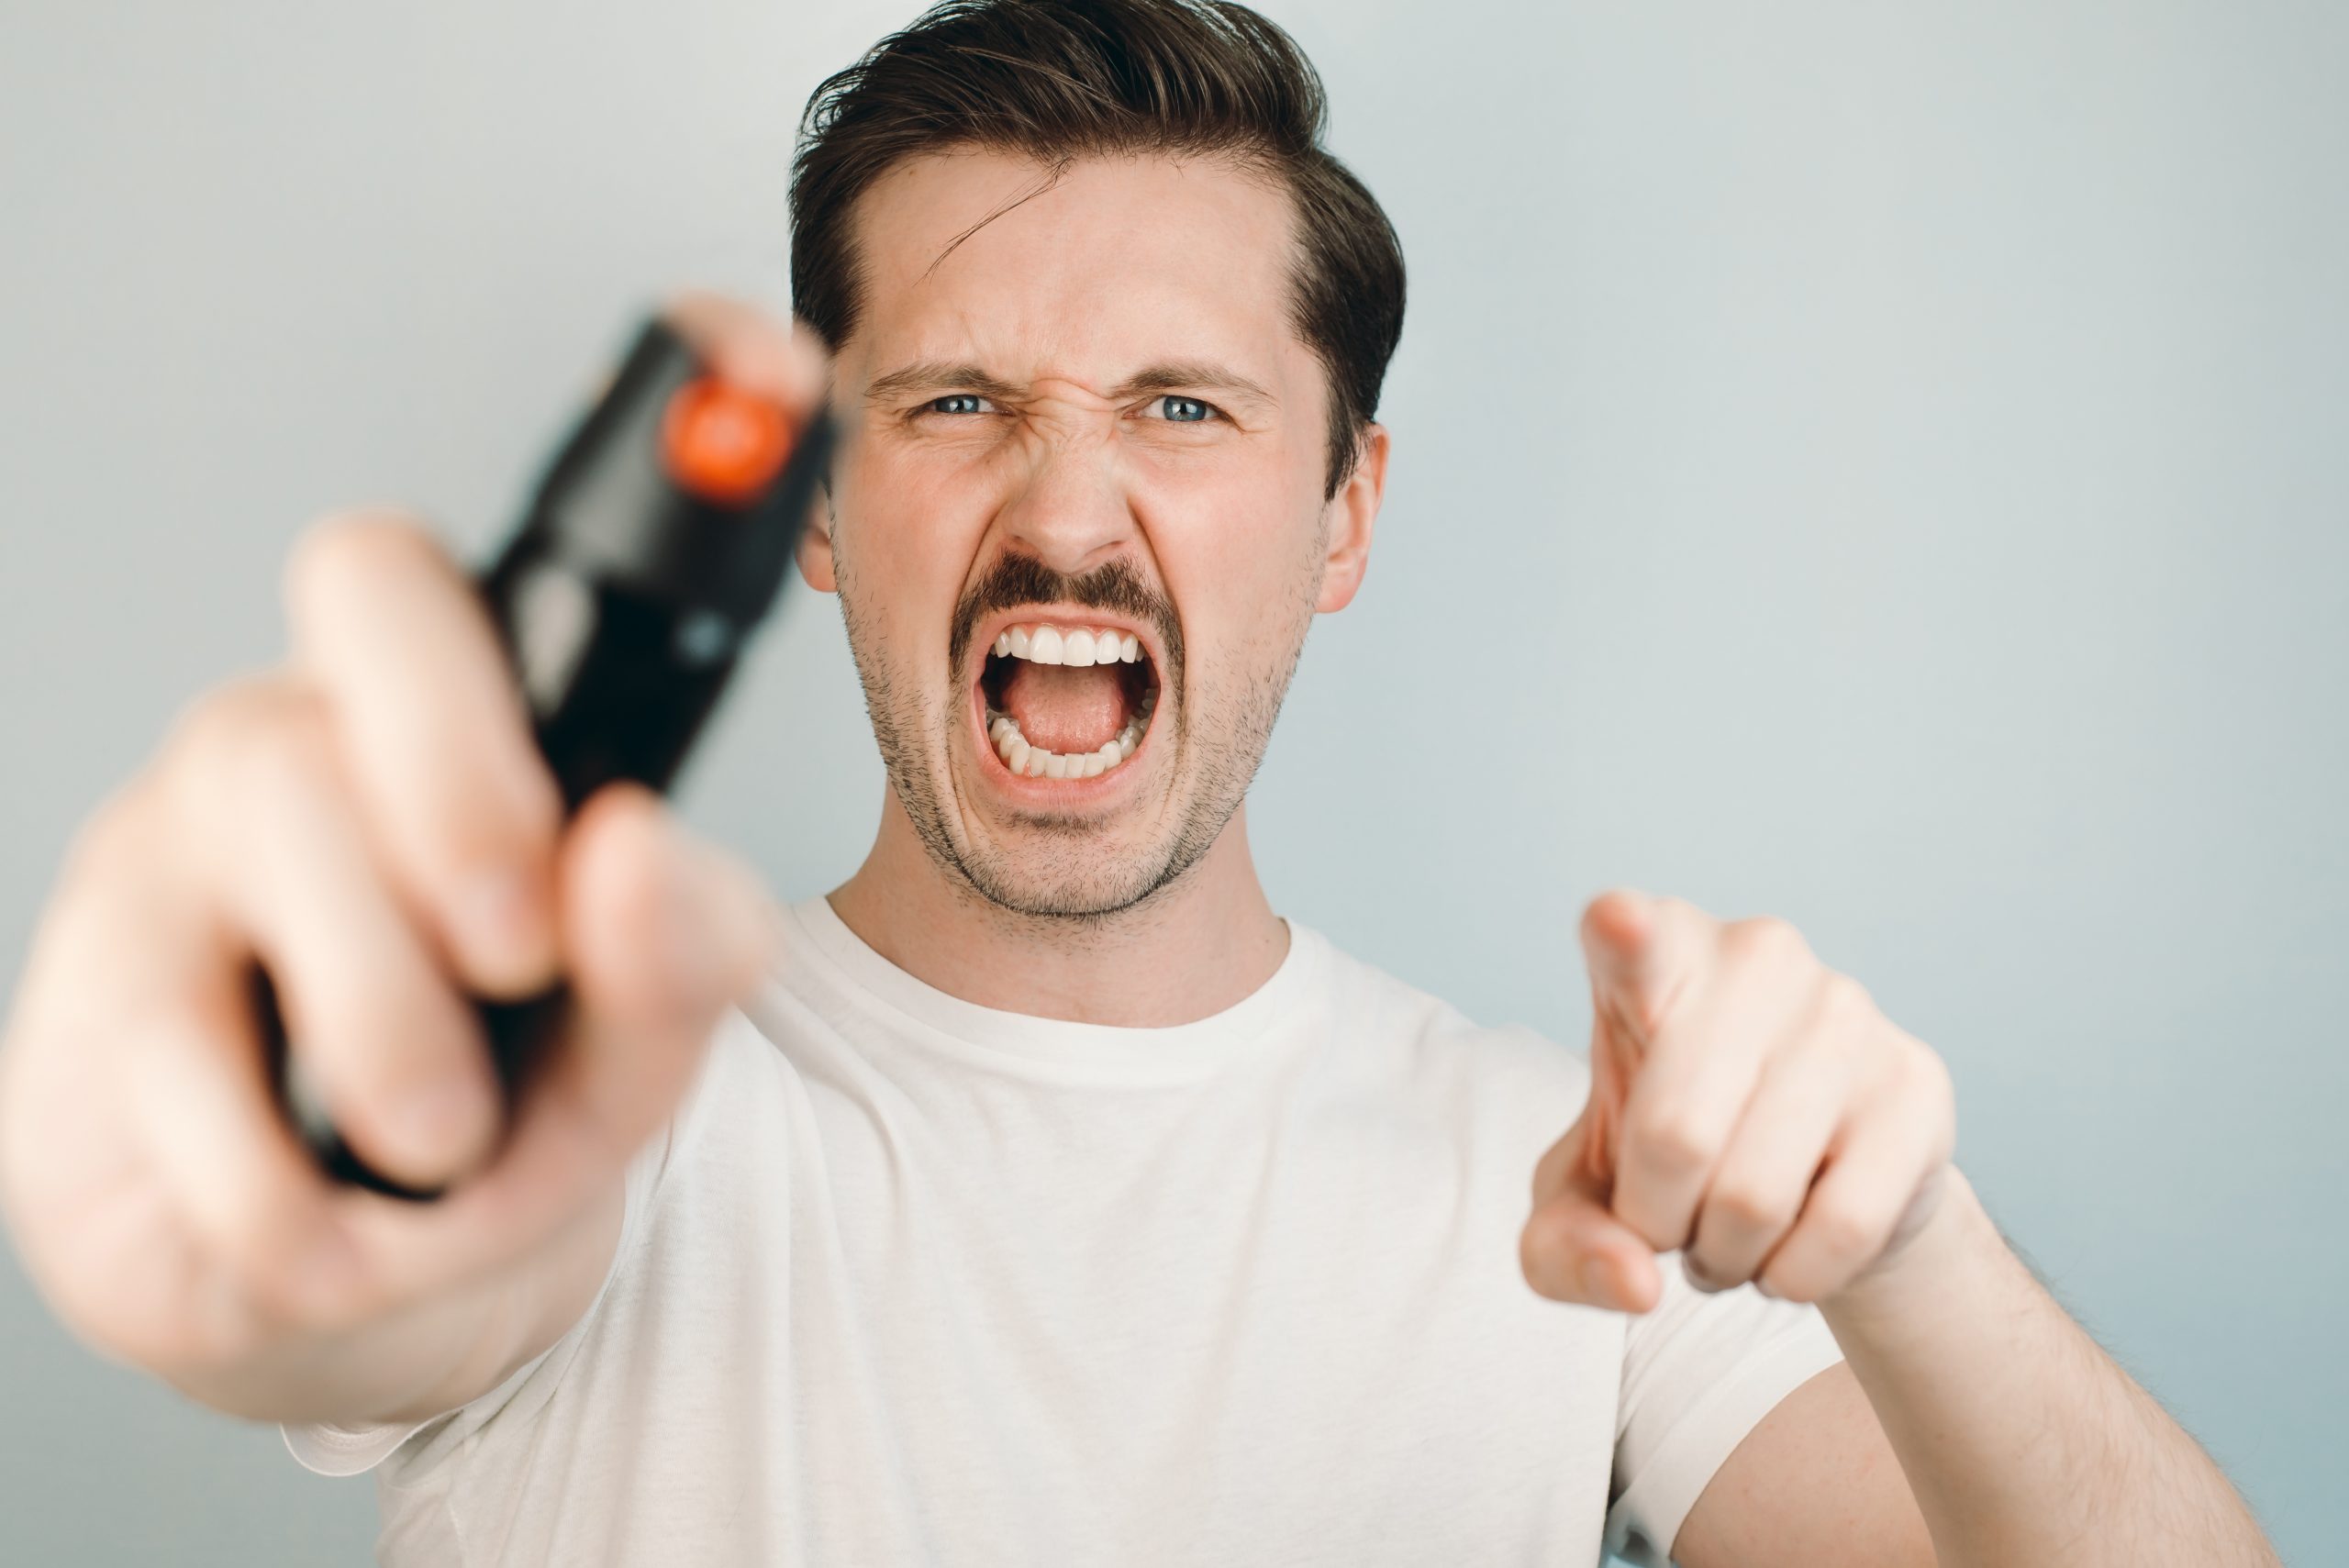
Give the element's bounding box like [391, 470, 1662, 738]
[253, 317, 831, 1199]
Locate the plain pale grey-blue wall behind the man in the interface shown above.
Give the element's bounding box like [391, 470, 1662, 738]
[0, 0, 2349, 1563]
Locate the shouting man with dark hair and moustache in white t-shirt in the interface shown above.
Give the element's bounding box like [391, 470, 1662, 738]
[0, 0, 2274, 1568]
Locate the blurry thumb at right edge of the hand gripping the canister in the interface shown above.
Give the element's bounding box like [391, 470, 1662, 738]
[562, 784, 773, 1151]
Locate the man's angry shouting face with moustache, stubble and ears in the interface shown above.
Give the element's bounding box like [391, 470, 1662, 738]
[804, 152, 1384, 916]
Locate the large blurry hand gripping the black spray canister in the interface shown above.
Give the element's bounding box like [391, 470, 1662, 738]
[0, 287, 818, 1422]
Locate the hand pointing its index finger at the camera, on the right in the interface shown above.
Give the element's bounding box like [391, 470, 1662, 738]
[1520, 892, 1956, 1312]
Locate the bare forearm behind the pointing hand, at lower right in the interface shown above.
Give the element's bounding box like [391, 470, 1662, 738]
[1820, 1169, 2277, 1568]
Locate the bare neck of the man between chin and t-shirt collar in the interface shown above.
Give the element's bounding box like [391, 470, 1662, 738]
[831, 794, 1289, 1029]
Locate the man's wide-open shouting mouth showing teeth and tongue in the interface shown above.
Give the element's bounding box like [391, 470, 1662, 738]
[980, 619, 1158, 779]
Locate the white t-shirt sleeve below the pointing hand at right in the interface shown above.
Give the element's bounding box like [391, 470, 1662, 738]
[1607, 1251, 1844, 1568]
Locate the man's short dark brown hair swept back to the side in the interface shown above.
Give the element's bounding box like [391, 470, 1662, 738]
[792, 0, 1402, 495]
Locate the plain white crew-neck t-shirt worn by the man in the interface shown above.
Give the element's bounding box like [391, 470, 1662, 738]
[286, 899, 1842, 1568]
